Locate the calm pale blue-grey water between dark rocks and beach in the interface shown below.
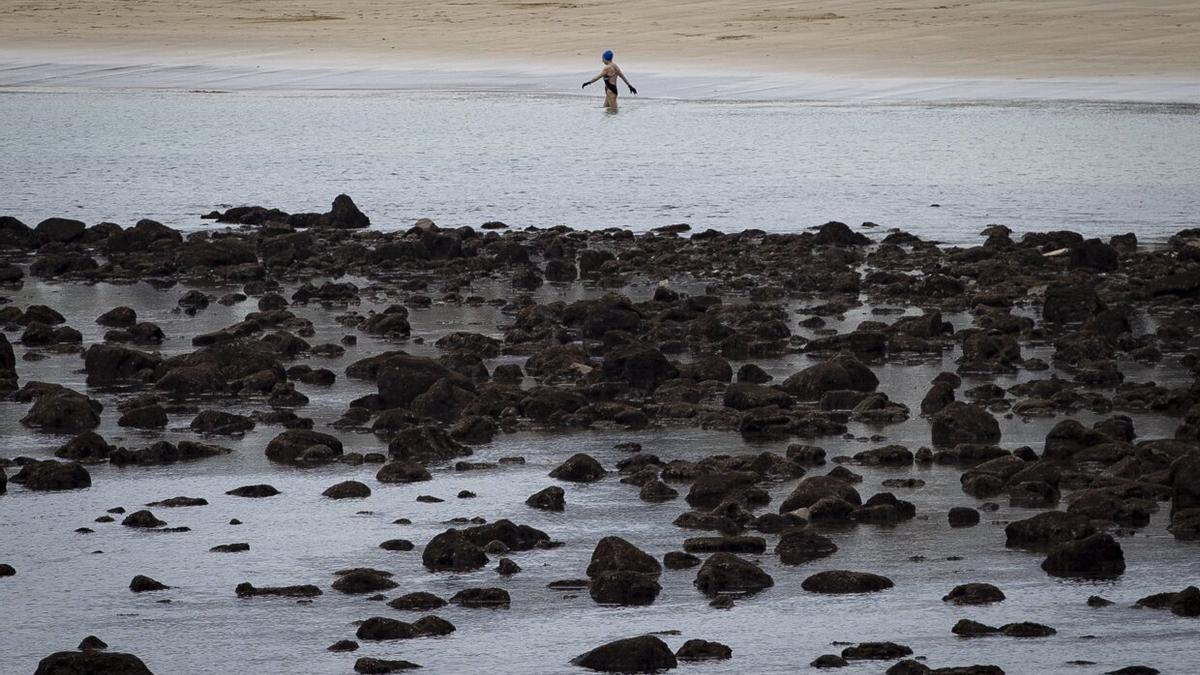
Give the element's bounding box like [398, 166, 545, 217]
[0, 88, 1200, 243]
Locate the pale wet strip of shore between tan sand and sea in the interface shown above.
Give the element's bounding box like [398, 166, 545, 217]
[7, 49, 1200, 104]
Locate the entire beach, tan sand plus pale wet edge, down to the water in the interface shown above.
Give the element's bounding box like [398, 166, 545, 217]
[0, 0, 1200, 101]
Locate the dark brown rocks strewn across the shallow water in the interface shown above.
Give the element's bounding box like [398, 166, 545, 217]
[0, 195, 1200, 674]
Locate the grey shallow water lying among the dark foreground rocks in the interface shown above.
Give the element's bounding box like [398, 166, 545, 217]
[0, 275, 1200, 675]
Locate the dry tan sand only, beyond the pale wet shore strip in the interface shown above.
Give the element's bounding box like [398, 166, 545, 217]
[0, 0, 1200, 90]
